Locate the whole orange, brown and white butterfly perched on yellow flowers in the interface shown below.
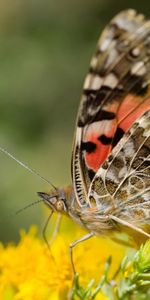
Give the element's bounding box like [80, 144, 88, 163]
[39, 9, 150, 271]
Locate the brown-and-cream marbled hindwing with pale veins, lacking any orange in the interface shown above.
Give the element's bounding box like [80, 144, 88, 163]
[89, 111, 150, 239]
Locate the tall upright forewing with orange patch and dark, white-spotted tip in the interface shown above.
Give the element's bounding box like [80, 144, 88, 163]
[72, 10, 150, 206]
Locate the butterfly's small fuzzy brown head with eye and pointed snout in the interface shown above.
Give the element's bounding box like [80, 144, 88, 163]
[38, 189, 68, 214]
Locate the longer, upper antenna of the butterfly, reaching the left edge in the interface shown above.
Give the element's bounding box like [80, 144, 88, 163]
[0, 146, 57, 191]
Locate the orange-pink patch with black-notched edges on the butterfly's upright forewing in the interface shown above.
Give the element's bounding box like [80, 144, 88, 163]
[83, 94, 150, 172]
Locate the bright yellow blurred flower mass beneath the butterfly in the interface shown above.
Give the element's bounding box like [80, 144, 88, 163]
[0, 218, 126, 300]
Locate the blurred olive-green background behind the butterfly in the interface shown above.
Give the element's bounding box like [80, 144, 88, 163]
[0, 0, 150, 242]
